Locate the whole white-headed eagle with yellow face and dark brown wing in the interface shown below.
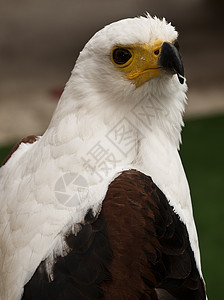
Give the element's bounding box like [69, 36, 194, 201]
[0, 14, 207, 300]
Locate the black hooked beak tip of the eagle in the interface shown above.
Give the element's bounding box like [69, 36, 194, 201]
[158, 42, 184, 84]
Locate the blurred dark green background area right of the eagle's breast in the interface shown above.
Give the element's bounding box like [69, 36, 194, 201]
[181, 115, 224, 300]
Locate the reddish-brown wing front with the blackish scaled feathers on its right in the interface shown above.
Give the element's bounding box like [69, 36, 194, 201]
[102, 170, 205, 299]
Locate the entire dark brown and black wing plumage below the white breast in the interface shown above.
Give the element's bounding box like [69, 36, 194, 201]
[22, 170, 205, 300]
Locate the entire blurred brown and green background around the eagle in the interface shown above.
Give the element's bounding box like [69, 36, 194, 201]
[0, 0, 224, 299]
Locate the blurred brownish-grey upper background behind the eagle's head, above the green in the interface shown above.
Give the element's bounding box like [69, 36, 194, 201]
[0, 0, 224, 145]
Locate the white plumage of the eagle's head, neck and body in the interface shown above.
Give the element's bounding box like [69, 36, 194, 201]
[0, 15, 203, 300]
